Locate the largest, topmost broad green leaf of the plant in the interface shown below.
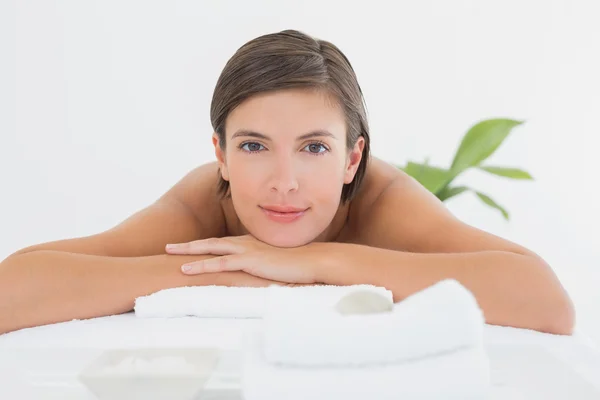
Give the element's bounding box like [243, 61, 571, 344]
[450, 118, 524, 176]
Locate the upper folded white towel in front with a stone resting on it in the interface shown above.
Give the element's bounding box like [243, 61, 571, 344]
[264, 280, 485, 366]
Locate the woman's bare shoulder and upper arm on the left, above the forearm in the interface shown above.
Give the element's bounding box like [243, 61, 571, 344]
[5, 163, 225, 257]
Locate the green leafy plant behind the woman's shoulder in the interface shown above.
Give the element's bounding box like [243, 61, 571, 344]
[398, 118, 533, 220]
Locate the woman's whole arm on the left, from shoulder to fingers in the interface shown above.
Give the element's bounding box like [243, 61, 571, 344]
[0, 164, 272, 333]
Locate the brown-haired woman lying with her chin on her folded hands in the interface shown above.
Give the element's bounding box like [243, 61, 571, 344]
[0, 31, 574, 334]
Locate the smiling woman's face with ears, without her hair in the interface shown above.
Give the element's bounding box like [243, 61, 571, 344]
[213, 89, 364, 247]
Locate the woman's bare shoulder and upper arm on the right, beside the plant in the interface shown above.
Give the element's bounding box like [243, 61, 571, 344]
[350, 160, 533, 255]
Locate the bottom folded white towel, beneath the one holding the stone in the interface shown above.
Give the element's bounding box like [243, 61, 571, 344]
[241, 333, 490, 400]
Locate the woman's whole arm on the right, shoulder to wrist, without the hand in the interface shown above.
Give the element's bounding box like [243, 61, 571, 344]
[322, 173, 575, 334]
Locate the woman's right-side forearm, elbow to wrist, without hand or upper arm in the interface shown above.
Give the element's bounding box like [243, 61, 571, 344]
[321, 244, 574, 334]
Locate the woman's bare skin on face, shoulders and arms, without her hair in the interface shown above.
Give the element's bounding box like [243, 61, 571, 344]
[0, 87, 574, 334]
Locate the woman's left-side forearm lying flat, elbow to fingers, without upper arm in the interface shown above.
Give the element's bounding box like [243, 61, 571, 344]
[0, 251, 275, 334]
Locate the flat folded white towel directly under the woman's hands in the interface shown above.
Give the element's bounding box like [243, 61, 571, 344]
[134, 285, 392, 318]
